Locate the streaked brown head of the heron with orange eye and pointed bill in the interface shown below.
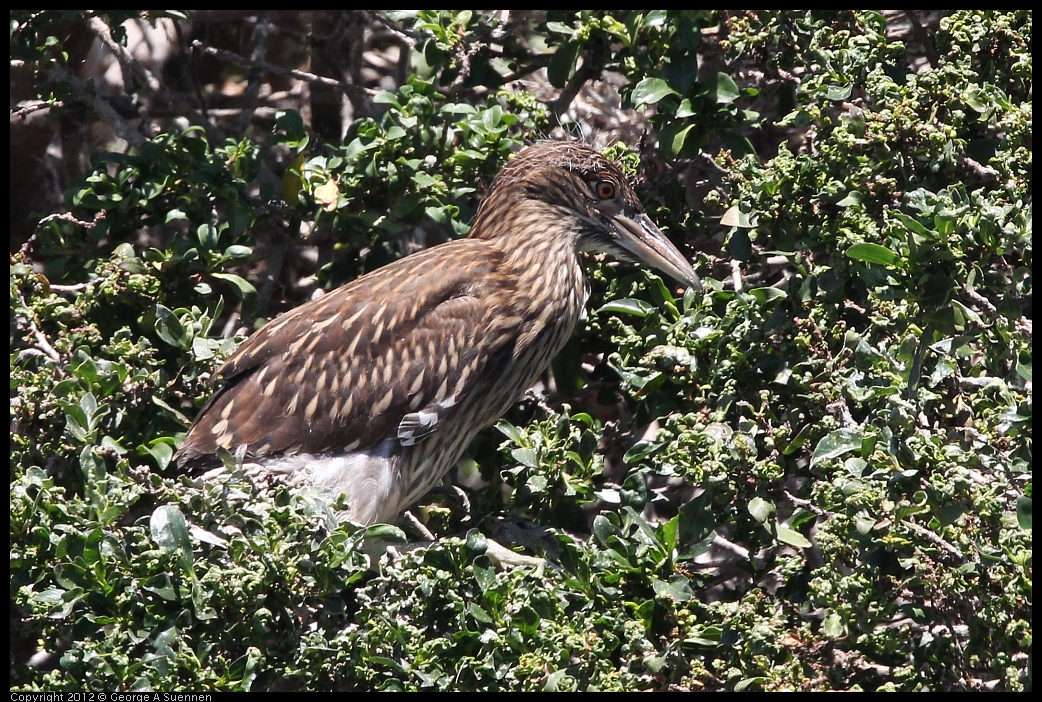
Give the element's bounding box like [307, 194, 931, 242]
[471, 142, 701, 290]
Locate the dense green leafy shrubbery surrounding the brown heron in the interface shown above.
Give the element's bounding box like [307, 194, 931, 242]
[10, 10, 1033, 693]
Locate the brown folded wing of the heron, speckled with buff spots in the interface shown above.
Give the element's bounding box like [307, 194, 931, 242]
[178, 240, 517, 465]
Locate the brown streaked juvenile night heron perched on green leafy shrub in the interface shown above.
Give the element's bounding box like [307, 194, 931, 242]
[177, 142, 700, 524]
